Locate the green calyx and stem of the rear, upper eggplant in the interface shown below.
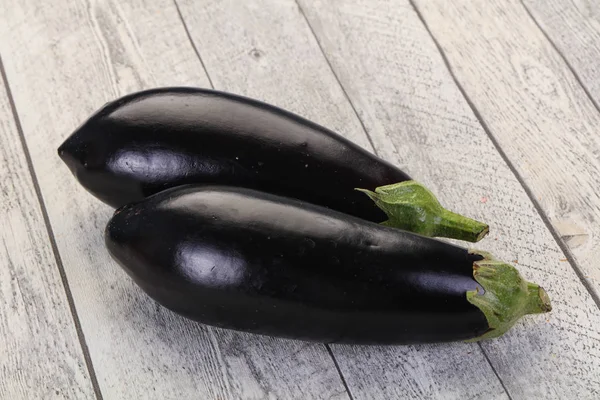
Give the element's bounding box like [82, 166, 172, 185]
[356, 181, 489, 242]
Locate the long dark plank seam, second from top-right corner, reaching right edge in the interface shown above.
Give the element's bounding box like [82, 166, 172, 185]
[408, 0, 600, 314]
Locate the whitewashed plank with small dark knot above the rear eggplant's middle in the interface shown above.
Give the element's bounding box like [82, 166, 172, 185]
[178, 0, 507, 400]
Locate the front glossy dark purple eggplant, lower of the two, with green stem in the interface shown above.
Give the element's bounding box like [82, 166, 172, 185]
[105, 185, 551, 344]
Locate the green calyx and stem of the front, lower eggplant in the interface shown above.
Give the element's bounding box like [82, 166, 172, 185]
[467, 251, 552, 342]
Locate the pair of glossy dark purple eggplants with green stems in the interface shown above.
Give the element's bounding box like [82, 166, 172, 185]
[59, 88, 551, 344]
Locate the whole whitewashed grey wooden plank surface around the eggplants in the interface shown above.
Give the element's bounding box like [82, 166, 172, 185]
[0, 0, 600, 400]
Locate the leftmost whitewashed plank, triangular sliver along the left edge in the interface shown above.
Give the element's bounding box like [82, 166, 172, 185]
[0, 75, 94, 400]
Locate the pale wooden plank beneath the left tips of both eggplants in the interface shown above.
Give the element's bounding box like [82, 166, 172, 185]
[0, 0, 348, 400]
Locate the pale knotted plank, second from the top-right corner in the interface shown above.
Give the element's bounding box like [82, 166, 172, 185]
[419, 0, 600, 302]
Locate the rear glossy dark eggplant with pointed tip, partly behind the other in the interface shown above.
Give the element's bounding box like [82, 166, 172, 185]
[58, 87, 488, 242]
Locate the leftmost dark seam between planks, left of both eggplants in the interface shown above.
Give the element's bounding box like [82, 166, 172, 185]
[0, 55, 103, 400]
